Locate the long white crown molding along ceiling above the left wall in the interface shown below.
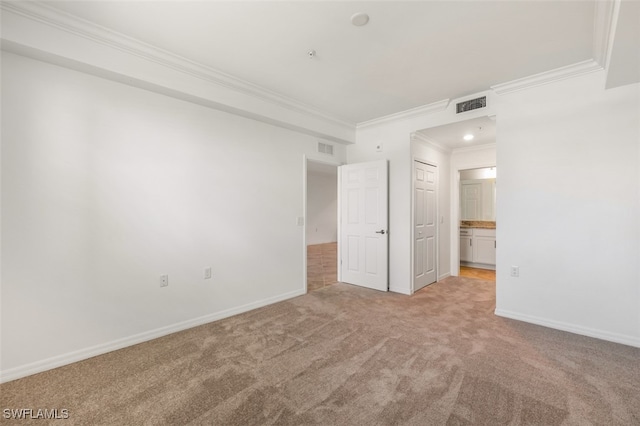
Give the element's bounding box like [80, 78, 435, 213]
[0, 1, 355, 129]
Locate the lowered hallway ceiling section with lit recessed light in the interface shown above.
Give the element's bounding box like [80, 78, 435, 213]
[416, 117, 496, 150]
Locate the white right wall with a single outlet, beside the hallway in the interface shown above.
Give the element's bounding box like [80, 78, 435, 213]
[496, 72, 640, 346]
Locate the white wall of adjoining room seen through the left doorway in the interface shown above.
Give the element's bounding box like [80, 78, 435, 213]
[307, 170, 338, 245]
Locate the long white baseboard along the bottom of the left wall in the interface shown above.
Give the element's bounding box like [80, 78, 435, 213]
[0, 289, 306, 383]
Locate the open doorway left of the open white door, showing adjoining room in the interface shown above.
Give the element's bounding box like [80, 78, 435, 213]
[305, 160, 338, 292]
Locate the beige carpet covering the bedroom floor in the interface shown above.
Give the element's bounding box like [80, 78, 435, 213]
[0, 278, 640, 426]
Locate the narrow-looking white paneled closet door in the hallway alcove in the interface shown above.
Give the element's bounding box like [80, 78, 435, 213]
[413, 161, 437, 291]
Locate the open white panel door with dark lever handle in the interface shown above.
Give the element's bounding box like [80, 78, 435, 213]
[339, 160, 389, 291]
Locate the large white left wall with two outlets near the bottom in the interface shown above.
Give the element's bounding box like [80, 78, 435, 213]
[1, 53, 345, 380]
